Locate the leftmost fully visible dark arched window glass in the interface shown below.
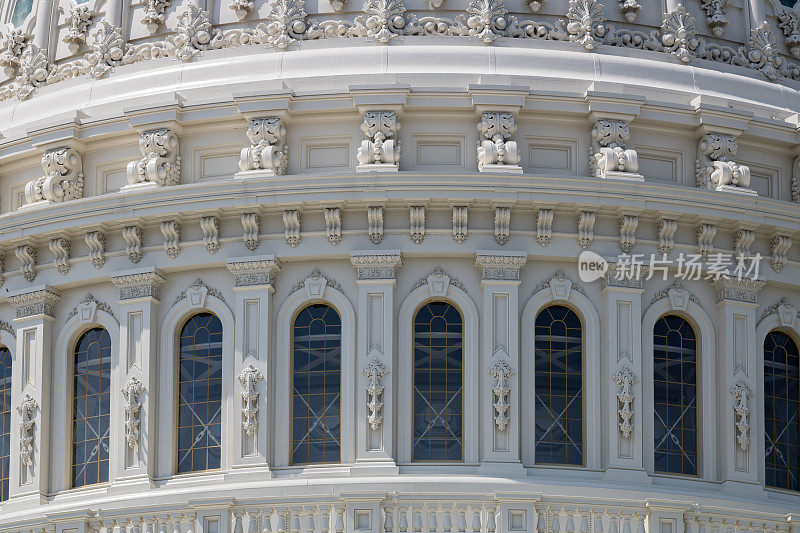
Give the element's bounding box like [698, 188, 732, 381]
[72, 328, 111, 487]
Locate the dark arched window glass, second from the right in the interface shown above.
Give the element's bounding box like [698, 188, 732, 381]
[653, 315, 697, 476]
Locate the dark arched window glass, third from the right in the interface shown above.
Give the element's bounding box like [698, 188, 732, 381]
[534, 305, 583, 465]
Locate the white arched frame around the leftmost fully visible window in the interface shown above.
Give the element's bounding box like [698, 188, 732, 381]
[49, 303, 119, 492]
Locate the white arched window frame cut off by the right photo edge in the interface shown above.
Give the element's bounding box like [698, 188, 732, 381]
[750, 308, 800, 495]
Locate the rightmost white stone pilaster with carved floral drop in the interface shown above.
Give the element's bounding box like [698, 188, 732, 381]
[706, 279, 765, 491]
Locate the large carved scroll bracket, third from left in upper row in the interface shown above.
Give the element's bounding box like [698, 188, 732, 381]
[239, 117, 289, 175]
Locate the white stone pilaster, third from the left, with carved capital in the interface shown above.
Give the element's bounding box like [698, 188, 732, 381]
[225, 255, 278, 479]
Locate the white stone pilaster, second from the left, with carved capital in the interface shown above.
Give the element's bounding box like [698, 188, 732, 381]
[109, 267, 165, 483]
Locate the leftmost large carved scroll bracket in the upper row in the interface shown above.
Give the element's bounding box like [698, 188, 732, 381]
[25, 146, 83, 204]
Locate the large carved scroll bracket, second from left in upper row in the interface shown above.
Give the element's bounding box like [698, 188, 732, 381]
[128, 128, 181, 187]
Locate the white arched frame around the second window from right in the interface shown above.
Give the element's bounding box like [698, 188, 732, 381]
[641, 296, 716, 480]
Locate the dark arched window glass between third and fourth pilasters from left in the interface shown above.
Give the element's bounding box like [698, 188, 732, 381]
[292, 304, 342, 464]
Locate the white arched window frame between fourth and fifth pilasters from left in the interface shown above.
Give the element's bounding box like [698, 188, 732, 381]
[397, 284, 480, 465]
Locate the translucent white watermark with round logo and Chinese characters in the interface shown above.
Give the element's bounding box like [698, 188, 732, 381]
[578, 250, 761, 283]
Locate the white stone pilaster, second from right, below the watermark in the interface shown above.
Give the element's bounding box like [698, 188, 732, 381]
[600, 272, 644, 476]
